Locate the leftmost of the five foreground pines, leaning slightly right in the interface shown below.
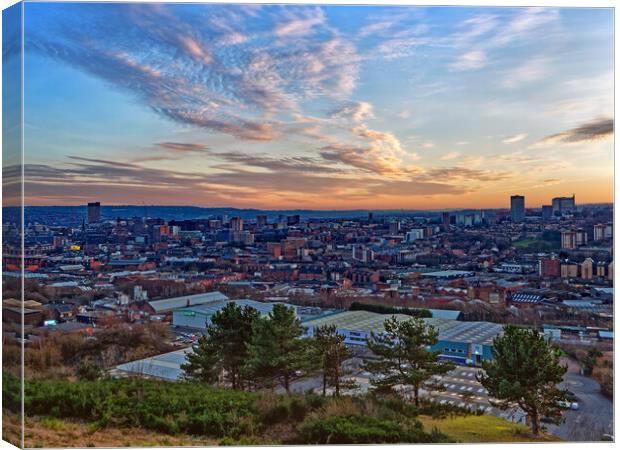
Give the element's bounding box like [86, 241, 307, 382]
[182, 302, 260, 389]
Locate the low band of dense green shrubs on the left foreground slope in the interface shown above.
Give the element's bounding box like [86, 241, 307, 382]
[24, 379, 256, 438]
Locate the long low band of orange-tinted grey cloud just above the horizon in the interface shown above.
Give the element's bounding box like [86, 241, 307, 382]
[19, 149, 472, 208]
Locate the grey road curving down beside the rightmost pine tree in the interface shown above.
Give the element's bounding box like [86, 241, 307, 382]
[545, 358, 614, 442]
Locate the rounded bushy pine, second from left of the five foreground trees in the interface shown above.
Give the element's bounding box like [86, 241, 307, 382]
[246, 305, 314, 393]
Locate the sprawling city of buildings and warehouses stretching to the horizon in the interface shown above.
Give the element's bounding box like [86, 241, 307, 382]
[3, 195, 613, 440]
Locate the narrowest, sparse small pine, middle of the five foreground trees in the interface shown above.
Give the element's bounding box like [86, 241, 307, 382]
[313, 325, 357, 397]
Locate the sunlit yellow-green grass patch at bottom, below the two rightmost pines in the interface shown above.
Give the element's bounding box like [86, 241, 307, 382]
[418, 415, 561, 443]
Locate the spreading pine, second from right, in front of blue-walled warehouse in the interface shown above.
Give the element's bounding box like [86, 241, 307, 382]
[364, 316, 454, 406]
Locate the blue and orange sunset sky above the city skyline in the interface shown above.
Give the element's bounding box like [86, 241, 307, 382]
[15, 3, 613, 209]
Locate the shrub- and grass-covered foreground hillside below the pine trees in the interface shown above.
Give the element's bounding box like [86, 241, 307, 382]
[3, 374, 560, 447]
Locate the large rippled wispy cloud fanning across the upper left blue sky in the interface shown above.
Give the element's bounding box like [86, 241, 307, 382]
[27, 4, 360, 141]
